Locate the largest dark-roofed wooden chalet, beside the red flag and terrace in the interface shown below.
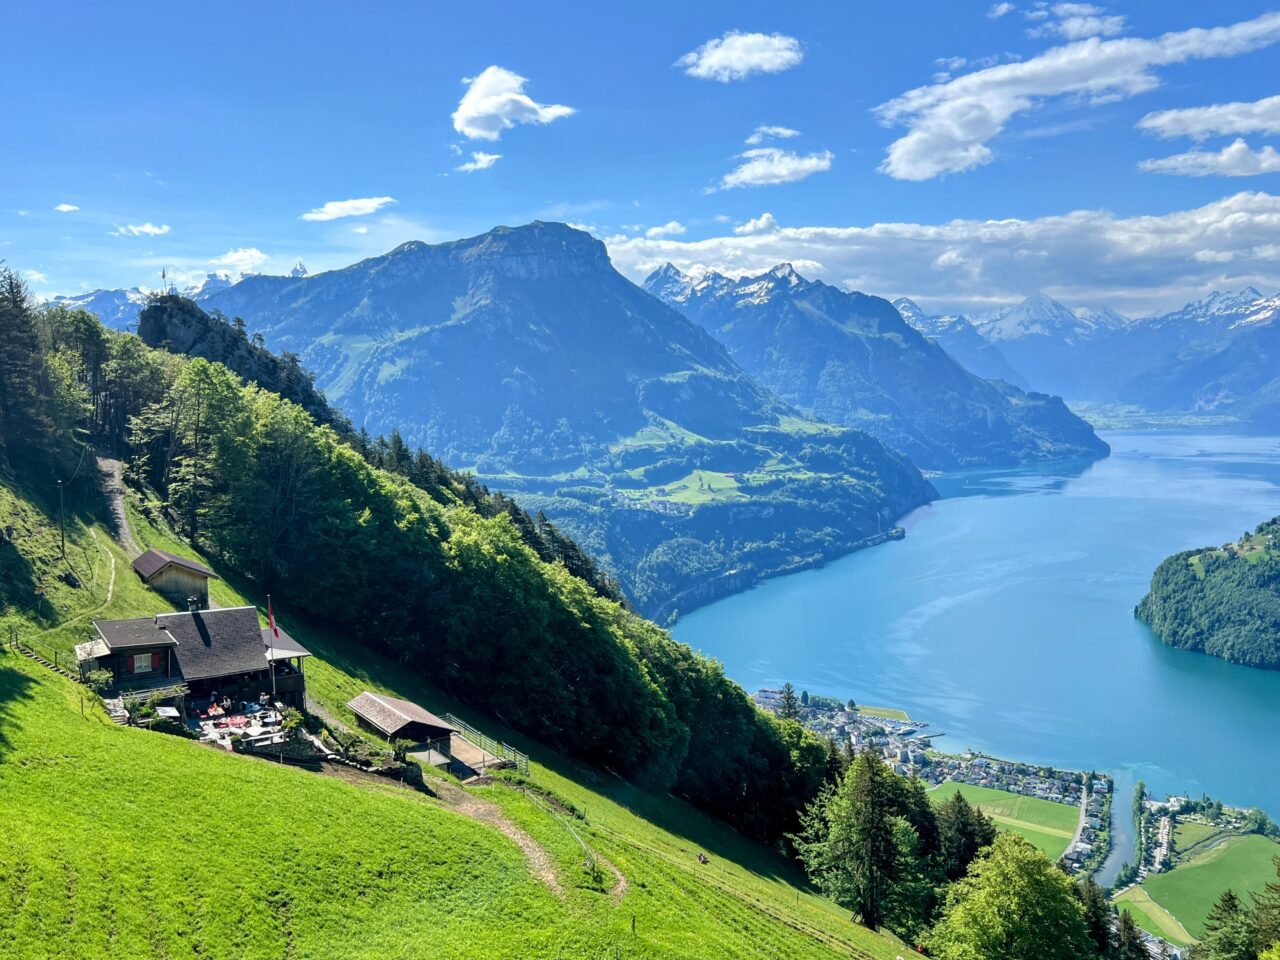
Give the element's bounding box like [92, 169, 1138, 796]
[76, 607, 311, 708]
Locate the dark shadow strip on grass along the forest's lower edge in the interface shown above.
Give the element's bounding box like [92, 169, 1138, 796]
[293, 612, 808, 887]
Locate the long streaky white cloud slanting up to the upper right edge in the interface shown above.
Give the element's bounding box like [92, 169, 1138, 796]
[874, 13, 1280, 180]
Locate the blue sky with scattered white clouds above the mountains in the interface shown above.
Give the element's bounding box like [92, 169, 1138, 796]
[0, 0, 1280, 314]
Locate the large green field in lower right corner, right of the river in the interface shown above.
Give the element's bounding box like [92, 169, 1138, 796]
[1121, 833, 1280, 937]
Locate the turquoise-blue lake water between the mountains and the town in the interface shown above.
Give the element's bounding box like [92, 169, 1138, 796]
[675, 431, 1280, 881]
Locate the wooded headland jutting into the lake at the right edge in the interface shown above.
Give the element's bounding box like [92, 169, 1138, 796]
[1135, 518, 1280, 669]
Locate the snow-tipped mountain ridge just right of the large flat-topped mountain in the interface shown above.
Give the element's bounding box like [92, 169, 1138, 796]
[645, 264, 1107, 468]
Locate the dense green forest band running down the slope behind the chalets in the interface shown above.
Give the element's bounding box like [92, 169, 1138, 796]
[0, 271, 828, 840]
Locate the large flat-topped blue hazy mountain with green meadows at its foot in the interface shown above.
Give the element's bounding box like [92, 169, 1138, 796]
[202, 223, 934, 616]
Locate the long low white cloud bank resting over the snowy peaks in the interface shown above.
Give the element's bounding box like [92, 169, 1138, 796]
[605, 192, 1280, 315]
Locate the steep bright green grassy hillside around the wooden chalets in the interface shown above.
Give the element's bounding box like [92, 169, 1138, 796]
[0, 488, 901, 960]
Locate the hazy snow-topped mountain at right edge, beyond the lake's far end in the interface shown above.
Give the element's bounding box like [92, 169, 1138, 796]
[1120, 295, 1280, 429]
